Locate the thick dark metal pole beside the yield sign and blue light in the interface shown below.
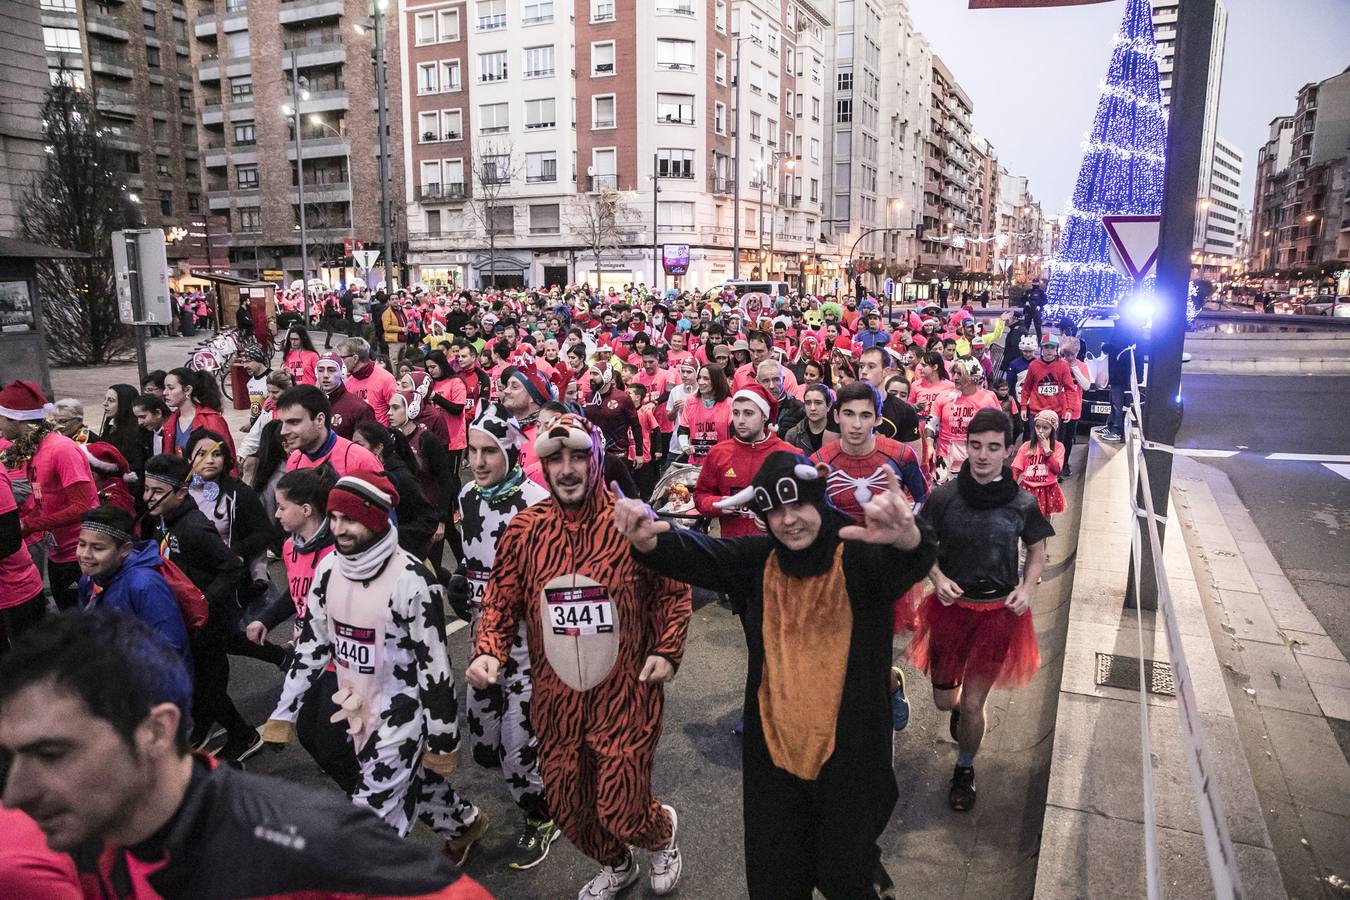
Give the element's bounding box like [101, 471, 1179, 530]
[1125, 0, 1216, 610]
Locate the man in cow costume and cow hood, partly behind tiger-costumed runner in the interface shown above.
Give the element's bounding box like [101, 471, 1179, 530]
[450, 403, 559, 869]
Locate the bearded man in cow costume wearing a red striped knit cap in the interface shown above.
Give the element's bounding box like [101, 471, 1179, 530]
[261, 470, 487, 865]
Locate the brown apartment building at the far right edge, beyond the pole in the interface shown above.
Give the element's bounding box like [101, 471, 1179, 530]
[1249, 69, 1350, 282]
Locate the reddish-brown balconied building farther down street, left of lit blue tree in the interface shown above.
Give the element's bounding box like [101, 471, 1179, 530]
[919, 54, 976, 274]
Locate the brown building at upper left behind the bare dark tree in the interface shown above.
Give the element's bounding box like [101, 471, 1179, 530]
[38, 0, 205, 262]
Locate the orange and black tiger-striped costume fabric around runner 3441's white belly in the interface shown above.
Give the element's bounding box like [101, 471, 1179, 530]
[474, 424, 691, 866]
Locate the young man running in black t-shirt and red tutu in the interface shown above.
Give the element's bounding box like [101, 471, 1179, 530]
[909, 409, 1054, 812]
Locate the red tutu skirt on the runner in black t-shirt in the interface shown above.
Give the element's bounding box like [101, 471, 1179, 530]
[907, 594, 1041, 687]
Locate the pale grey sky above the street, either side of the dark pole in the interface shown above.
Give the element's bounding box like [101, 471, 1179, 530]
[910, 0, 1350, 213]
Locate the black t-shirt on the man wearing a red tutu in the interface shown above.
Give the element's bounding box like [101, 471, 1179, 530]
[919, 479, 1054, 592]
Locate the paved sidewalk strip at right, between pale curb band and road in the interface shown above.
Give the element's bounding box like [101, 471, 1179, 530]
[1172, 457, 1350, 897]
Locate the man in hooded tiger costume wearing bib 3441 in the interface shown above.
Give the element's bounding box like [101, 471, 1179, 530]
[467, 414, 691, 900]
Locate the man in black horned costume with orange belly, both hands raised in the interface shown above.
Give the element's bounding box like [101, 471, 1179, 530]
[614, 452, 937, 900]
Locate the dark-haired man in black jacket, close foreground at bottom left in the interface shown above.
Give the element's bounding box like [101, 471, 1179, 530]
[0, 610, 489, 900]
